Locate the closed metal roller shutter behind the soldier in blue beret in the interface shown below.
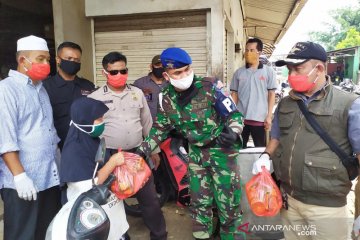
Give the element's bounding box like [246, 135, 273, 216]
[94, 11, 208, 86]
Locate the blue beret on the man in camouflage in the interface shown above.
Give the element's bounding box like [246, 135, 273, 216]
[160, 48, 192, 68]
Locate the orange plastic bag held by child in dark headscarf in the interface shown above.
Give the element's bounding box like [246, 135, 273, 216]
[111, 152, 151, 199]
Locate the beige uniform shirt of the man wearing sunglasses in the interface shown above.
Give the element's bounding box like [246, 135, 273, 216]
[89, 85, 152, 150]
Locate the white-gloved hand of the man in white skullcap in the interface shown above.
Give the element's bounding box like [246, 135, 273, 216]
[14, 172, 38, 201]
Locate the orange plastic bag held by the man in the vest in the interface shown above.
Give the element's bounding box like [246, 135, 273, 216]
[245, 167, 282, 217]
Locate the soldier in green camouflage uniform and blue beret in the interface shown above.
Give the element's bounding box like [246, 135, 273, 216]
[137, 48, 244, 239]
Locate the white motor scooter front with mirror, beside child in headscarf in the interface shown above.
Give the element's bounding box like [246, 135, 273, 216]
[45, 139, 129, 240]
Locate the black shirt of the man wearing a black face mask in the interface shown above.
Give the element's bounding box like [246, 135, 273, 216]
[43, 73, 95, 149]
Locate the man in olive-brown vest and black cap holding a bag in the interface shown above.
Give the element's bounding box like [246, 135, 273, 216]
[253, 42, 360, 239]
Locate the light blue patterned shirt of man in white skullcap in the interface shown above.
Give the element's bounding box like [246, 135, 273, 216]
[0, 70, 60, 191]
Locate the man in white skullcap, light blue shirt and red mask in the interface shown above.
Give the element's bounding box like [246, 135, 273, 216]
[0, 36, 61, 240]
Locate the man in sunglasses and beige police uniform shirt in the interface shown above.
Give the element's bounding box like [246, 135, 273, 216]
[89, 52, 167, 240]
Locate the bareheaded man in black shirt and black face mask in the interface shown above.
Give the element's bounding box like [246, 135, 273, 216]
[44, 42, 95, 149]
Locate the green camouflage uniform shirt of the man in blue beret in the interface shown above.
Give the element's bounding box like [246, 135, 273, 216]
[140, 76, 243, 158]
